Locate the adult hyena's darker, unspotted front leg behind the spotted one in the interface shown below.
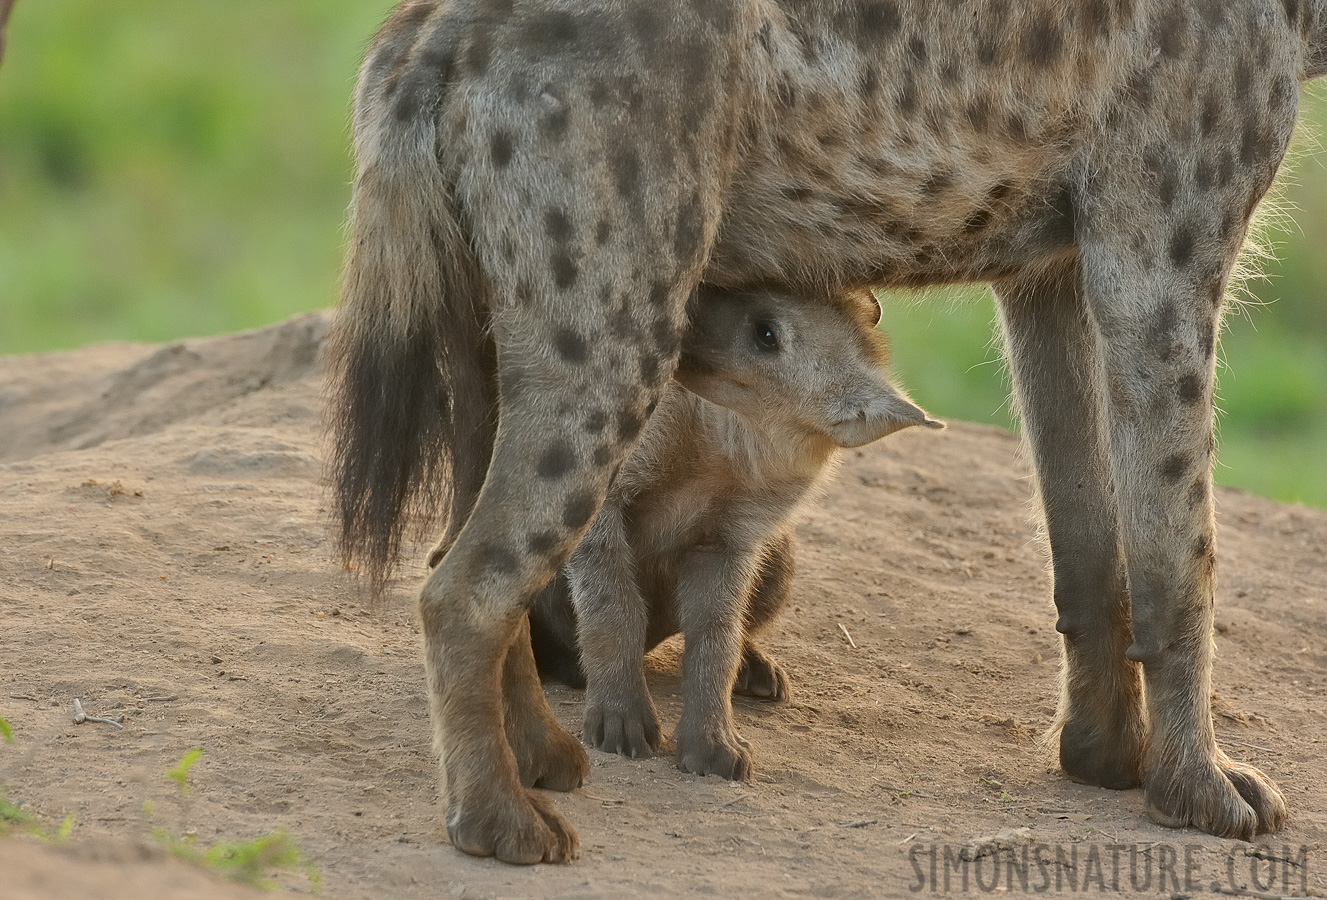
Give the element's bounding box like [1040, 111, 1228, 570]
[997, 262, 1147, 788]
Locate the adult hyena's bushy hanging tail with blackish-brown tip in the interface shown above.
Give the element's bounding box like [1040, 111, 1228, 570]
[328, 98, 496, 597]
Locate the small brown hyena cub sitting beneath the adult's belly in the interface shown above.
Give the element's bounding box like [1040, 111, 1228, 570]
[531, 288, 941, 781]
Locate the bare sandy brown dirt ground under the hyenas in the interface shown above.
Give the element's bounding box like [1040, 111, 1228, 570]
[0, 316, 1327, 900]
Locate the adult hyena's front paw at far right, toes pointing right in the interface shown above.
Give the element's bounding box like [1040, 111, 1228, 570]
[1145, 750, 1286, 840]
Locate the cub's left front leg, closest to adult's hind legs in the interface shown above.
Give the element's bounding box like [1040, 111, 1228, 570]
[567, 498, 660, 758]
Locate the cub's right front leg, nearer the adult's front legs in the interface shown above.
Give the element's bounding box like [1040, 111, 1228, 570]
[677, 546, 758, 781]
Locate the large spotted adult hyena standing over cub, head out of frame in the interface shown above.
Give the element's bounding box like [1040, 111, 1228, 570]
[323, 0, 1327, 862]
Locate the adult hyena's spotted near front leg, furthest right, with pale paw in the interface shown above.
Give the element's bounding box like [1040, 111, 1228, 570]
[1083, 224, 1286, 840]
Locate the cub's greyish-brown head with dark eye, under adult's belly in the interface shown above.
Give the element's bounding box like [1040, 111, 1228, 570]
[675, 285, 943, 447]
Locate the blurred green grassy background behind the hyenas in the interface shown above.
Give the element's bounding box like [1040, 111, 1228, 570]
[0, 0, 1327, 507]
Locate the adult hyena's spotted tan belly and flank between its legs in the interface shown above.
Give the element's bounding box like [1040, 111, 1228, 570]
[706, 3, 1130, 288]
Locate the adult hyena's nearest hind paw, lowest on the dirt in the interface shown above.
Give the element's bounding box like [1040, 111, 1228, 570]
[447, 788, 580, 865]
